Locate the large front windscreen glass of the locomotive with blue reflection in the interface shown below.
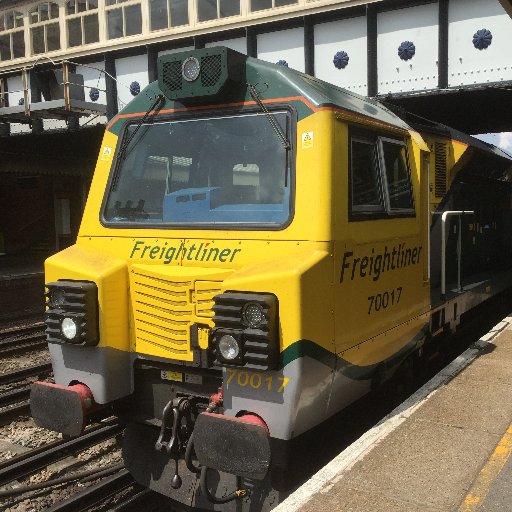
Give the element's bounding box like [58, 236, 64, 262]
[104, 112, 291, 227]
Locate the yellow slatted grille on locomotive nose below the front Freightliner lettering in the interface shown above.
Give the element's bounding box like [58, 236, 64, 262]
[130, 266, 220, 361]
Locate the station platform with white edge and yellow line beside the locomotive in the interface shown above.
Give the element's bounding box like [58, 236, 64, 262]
[274, 317, 512, 512]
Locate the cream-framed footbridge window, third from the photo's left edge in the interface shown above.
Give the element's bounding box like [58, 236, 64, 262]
[66, 0, 100, 46]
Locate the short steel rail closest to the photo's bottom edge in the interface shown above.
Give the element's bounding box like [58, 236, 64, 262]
[46, 469, 136, 512]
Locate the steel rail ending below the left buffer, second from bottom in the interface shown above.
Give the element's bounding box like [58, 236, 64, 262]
[0, 422, 123, 486]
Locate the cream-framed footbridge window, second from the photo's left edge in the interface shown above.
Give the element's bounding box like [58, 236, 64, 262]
[28, 2, 60, 55]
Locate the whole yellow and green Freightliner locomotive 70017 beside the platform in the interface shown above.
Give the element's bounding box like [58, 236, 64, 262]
[31, 47, 512, 510]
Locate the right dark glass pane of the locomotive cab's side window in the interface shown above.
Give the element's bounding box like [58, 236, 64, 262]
[382, 141, 413, 209]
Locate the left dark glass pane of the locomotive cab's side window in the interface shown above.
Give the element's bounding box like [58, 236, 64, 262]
[351, 140, 382, 211]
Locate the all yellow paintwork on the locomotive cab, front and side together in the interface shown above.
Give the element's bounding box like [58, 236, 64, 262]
[46, 109, 430, 366]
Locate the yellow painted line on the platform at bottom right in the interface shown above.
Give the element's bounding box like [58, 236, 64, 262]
[459, 425, 512, 512]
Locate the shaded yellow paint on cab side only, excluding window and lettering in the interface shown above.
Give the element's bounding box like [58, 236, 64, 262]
[334, 123, 430, 366]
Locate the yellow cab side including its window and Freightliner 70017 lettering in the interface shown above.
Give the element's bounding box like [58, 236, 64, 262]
[334, 121, 428, 381]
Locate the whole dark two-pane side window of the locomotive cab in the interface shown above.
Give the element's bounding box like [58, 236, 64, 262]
[349, 131, 415, 220]
